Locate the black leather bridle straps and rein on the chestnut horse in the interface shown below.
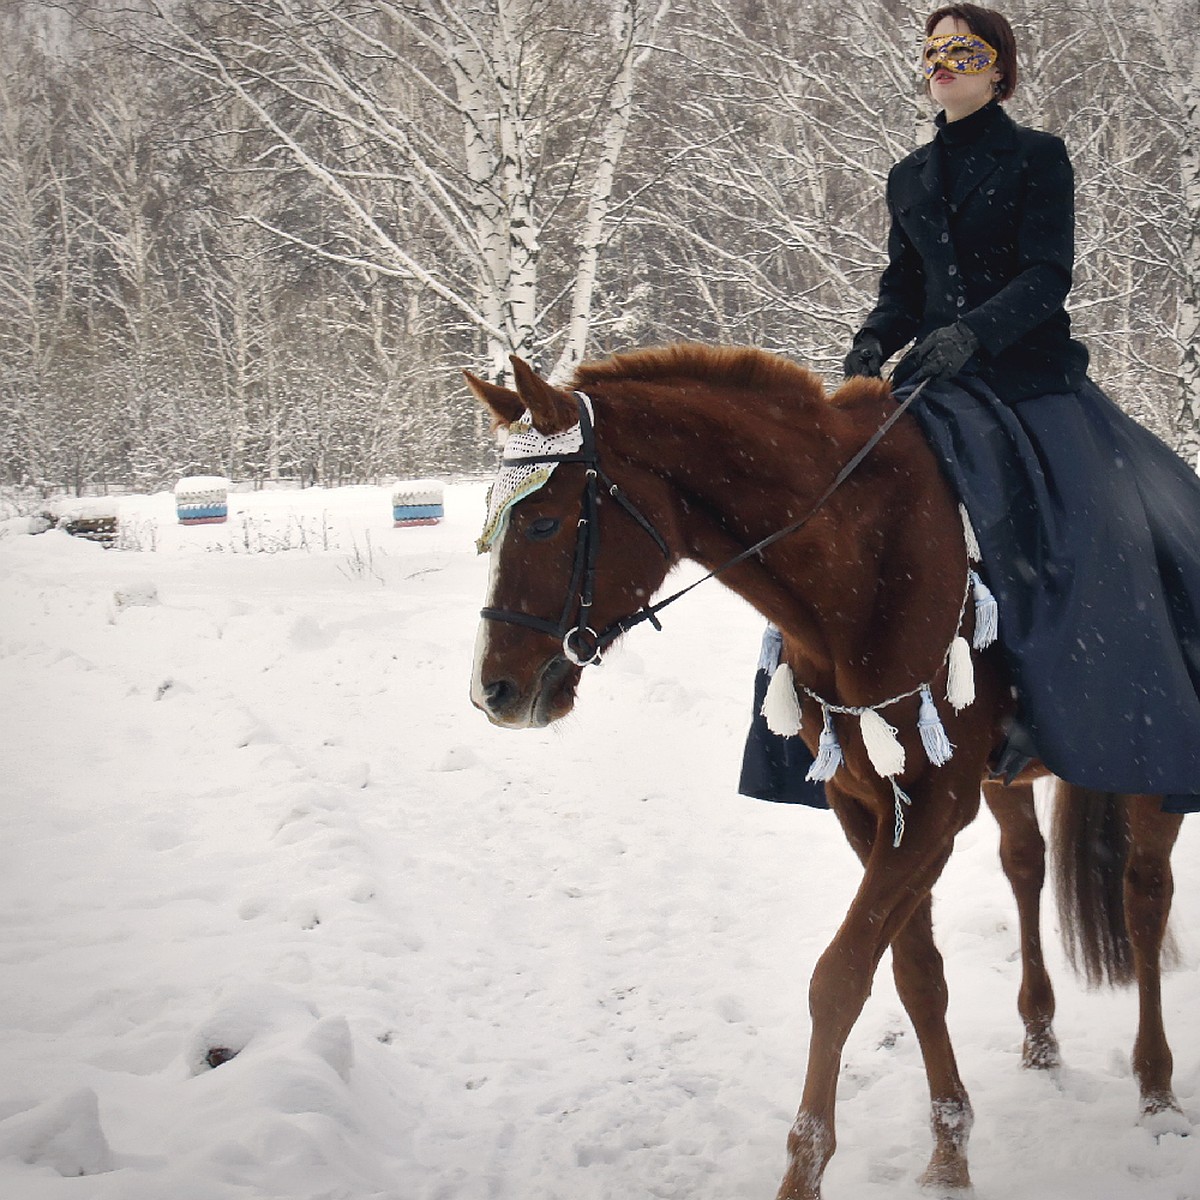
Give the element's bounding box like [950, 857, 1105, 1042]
[480, 380, 929, 667]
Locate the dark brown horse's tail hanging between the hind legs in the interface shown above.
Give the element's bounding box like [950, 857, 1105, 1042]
[1051, 780, 1134, 988]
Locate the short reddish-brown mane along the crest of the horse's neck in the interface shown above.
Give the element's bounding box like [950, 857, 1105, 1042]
[574, 342, 826, 403]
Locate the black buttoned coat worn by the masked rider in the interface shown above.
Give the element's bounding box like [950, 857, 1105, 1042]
[859, 103, 1087, 403]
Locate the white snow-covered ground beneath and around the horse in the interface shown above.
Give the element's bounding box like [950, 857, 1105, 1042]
[0, 484, 1200, 1200]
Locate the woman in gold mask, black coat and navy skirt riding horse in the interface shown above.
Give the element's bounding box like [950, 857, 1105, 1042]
[740, 4, 1200, 811]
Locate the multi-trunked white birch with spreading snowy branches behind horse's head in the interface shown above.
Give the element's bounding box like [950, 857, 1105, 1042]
[139, 0, 667, 384]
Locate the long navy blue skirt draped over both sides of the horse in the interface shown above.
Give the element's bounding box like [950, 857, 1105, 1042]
[739, 376, 1200, 812]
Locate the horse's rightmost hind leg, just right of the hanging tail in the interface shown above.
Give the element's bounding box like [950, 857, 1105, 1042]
[1124, 796, 1183, 1128]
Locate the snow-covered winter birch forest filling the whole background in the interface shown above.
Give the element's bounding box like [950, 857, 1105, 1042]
[0, 0, 1200, 492]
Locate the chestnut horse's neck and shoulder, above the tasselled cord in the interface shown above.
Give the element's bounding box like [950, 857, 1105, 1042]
[609, 386, 966, 704]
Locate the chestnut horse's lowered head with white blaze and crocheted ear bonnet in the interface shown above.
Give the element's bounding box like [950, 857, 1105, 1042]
[467, 358, 671, 728]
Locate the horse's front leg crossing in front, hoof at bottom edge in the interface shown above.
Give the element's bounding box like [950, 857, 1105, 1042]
[779, 782, 978, 1200]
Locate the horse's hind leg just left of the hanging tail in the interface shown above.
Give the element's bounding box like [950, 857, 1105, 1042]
[983, 780, 1061, 1070]
